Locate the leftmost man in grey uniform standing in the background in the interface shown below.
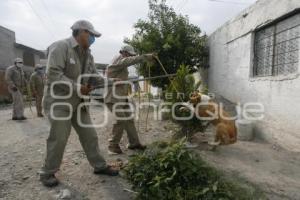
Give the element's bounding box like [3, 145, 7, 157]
[5, 58, 27, 120]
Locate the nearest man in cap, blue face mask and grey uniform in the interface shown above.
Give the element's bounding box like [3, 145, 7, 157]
[40, 20, 118, 187]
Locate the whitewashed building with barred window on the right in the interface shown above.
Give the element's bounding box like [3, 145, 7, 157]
[208, 0, 300, 151]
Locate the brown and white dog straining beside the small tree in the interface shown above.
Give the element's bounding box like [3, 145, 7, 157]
[183, 92, 237, 146]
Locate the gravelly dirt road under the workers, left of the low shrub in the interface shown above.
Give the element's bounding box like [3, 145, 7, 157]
[0, 104, 176, 200]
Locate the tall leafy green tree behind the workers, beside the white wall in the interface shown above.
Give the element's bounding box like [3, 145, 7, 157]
[125, 0, 208, 89]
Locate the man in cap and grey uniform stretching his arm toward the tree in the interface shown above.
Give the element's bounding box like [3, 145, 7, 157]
[104, 45, 154, 154]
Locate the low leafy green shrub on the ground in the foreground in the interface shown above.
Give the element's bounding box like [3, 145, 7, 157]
[123, 142, 264, 200]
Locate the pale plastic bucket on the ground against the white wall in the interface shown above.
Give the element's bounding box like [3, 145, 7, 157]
[235, 119, 254, 141]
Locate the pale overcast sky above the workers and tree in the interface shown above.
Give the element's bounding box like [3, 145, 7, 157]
[0, 0, 256, 63]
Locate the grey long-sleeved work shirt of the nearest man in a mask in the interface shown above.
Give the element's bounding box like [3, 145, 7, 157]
[43, 37, 105, 111]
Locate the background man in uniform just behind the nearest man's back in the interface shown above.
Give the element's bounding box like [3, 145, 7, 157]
[29, 64, 46, 117]
